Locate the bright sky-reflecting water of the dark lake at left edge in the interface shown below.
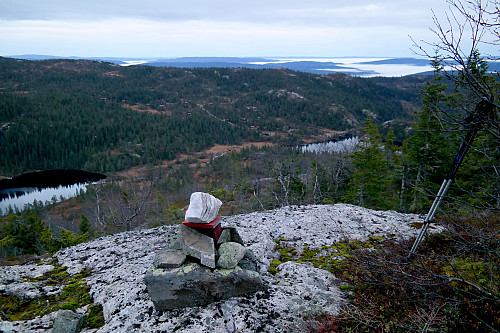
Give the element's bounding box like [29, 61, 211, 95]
[0, 184, 88, 215]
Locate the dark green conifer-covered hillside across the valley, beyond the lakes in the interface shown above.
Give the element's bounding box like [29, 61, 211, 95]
[0, 58, 425, 176]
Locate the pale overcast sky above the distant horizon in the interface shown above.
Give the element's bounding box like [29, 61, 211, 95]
[0, 0, 464, 57]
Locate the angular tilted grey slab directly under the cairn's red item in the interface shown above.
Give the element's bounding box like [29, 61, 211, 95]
[177, 224, 215, 268]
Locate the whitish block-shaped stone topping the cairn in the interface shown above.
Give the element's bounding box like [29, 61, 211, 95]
[185, 192, 222, 223]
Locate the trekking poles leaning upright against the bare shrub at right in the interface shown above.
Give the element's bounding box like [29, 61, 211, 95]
[406, 99, 495, 260]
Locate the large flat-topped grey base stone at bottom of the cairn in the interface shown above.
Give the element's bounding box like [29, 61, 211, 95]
[144, 263, 266, 311]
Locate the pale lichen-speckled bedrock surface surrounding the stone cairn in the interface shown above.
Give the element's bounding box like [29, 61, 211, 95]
[0, 204, 442, 333]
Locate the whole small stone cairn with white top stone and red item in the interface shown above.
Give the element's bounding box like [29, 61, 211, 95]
[144, 192, 266, 311]
